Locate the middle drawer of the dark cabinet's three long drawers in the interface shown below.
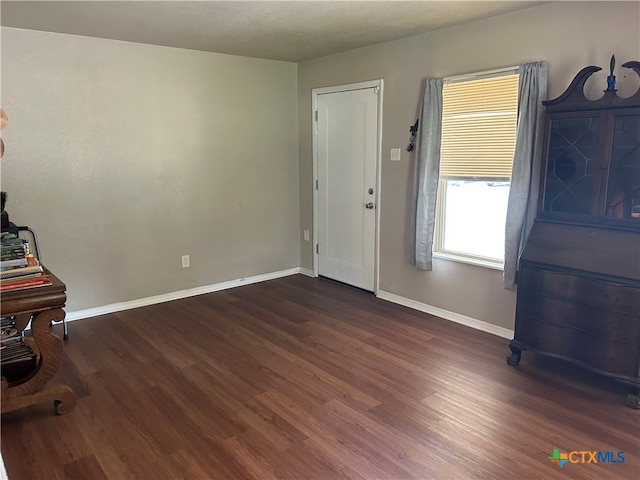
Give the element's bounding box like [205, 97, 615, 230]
[516, 292, 640, 346]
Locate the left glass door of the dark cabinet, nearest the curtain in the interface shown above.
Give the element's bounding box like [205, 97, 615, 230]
[542, 117, 599, 215]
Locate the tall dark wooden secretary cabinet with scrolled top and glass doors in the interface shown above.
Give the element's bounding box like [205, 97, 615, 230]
[507, 58, 640, 408]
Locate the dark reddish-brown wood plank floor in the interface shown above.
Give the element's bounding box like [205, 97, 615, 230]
[2, 275, 640, 480]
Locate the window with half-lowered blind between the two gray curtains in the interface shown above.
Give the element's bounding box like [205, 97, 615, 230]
[434, 69, 518, 268]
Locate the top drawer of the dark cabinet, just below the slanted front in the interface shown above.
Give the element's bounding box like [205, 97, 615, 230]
[518, 267, 640, 316]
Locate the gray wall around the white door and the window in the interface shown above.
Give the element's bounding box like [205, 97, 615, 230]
[298, 2, 640, 328]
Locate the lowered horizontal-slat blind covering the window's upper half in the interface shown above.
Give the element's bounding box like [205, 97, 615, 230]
[440, 74, 518, 179]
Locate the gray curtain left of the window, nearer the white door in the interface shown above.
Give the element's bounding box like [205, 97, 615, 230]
[411, 78, 443, 271]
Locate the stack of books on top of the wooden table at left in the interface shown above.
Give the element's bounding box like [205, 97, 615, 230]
[0, 232, 51, 292]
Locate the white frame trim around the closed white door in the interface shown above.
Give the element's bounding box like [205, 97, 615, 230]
[311, 79, 384, 295]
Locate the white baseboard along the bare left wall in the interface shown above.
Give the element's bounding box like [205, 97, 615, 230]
[65, 267, 302, 322]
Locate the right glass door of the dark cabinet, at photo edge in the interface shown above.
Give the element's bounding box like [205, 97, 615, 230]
[605, 115, 640, 220]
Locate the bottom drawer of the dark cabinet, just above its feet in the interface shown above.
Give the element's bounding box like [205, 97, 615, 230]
[515, 315, 640, 378]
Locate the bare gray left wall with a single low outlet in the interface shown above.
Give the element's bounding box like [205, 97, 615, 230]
[1, 28, 300, 311]
